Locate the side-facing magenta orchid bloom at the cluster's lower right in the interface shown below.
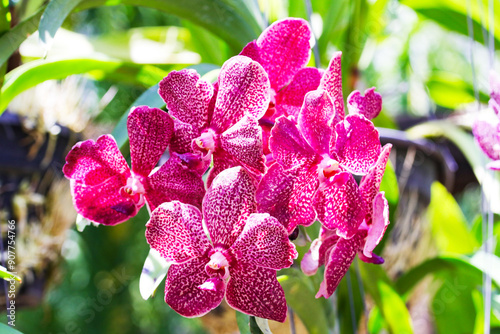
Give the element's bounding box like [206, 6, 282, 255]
[301, 145, 391, 298]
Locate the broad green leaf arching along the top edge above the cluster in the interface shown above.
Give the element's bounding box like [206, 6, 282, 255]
[77, 0, 264, 52]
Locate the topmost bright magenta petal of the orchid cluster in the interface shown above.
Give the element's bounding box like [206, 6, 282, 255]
[252, 18, 311, 92]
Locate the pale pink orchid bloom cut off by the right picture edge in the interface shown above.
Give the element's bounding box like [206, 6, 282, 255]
[472, 72, 500, 170]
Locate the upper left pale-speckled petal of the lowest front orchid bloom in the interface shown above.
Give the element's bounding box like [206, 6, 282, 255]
[146, 201, 210, 264]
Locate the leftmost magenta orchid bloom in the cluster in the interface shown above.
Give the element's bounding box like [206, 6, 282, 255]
[63, 106, 205, 225]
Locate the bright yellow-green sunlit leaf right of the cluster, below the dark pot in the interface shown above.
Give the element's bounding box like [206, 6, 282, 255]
[427, 182, 479, 254]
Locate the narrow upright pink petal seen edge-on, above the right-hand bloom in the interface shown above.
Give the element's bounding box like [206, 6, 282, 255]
[318, 51, 345, 120]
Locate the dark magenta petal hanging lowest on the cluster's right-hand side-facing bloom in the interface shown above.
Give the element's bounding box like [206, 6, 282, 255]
[316, 234, 363, 298]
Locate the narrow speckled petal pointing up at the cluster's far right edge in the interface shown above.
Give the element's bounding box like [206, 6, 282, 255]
[359, 144, 392, 218]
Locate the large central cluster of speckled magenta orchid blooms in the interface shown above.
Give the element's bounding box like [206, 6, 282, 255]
[63, 19, 391, 322]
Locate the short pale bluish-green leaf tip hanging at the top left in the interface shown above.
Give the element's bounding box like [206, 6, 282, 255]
[38, 0, 82, 49]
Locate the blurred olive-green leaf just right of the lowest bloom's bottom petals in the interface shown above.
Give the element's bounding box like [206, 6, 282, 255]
[278, 268, 329, 334]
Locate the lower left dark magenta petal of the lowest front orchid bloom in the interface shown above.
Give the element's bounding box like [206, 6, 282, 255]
[165, 257, 225, 318]
